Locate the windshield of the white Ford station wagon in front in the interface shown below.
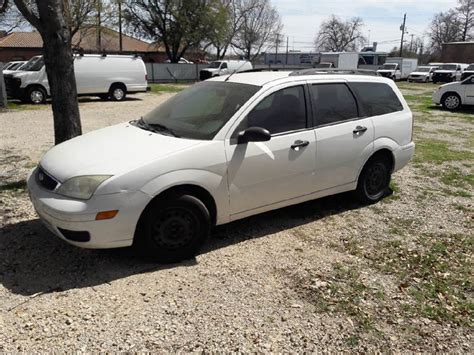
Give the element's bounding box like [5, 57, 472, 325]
[143, 81, 260, 140]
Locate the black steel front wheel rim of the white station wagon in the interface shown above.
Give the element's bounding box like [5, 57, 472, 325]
[151, 208, 197, 250]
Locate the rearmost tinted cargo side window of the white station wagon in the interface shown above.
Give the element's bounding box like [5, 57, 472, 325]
[350, 83, 403, 116]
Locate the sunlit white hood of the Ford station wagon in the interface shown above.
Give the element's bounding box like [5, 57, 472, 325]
[40, 123, 202, 182]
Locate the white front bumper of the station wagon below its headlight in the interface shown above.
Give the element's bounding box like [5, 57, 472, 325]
[27, 169, 151, 249]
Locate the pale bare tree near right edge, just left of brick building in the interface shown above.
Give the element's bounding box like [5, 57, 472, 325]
[428, 10, 462, 53]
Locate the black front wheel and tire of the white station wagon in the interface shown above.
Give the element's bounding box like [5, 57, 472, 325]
[134, 194, 211, 263]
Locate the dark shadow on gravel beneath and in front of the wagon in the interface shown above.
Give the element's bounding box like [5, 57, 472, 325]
[0, 194, 378, 296]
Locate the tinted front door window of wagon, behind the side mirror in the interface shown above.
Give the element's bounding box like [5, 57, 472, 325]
[237, 86, 307, 135]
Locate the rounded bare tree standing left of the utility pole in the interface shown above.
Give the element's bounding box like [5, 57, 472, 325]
[314, 15, 367, 52]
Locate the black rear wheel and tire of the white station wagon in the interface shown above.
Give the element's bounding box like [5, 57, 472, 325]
[355, 157, 392, 204]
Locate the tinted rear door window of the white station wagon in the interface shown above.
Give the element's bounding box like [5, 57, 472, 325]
[311, 84, 359, 126]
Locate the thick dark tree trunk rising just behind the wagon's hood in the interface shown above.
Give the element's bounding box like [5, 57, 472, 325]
[37, 0, 82, 144]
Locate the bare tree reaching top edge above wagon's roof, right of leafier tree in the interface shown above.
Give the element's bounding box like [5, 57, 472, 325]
[232, 0, 283, 61]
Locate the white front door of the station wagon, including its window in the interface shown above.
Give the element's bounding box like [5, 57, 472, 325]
[226, 85, 316, 219]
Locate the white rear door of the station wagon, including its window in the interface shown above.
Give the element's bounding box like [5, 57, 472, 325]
[310, 81, 374, 191]
